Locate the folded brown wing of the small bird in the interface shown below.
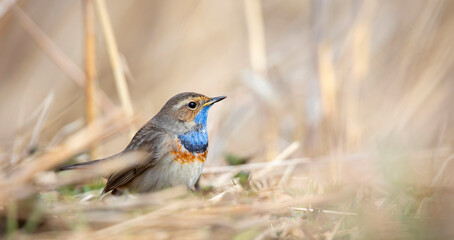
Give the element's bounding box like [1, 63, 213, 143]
[103, 123, 167, 193]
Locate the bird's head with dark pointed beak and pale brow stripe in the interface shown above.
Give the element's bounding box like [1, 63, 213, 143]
[156, 92, 226, 130]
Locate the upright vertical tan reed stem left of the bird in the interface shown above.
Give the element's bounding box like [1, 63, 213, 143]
[84, 0, 97, 159]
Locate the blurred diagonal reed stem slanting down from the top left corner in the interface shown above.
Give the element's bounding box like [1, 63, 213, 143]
[13, 5, 115, 112]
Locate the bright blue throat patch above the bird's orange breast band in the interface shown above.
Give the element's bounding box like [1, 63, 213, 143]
[178, 105, 211, 153]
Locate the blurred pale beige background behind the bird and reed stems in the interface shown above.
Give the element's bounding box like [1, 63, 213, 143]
[0, 0, 454, 169]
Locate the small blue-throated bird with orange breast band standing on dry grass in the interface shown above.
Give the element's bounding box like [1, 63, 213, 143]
[59, 92, 226, 195]
